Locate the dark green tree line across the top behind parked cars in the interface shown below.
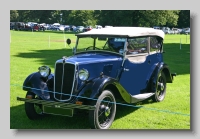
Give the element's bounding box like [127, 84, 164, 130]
[10, 10, 190, 28]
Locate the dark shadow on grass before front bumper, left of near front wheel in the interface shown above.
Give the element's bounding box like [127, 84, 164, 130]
[10, 104, 94, 129]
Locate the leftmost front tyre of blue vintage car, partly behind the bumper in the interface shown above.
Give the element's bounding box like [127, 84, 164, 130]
[25, 92, 44, 120]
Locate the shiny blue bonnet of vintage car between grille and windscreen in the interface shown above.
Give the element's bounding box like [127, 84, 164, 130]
[61, 53, 122, 88]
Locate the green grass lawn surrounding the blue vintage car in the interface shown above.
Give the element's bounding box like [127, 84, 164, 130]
[10, 31, 191, 129]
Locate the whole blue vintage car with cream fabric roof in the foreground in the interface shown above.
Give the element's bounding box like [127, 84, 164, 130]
[17, 27, 176, 129]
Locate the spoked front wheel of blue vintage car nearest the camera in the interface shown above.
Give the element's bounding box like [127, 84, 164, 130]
[89, 90, 116, 129]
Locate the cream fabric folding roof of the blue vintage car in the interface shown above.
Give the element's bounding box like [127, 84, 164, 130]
[76, 27, 165, 39]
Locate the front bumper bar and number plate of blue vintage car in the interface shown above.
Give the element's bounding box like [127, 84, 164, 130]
[17, 97, 95, 117]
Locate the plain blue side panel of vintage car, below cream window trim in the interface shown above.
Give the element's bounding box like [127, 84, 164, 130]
[119, 53, 162, 95]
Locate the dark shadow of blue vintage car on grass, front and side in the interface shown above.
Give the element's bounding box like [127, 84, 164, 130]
[10, 97, 155, 129]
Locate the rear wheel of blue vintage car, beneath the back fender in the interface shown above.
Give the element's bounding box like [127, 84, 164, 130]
[153, 72, 167, 102]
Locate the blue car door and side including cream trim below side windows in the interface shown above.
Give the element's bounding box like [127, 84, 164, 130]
[119, 36, 163, 95]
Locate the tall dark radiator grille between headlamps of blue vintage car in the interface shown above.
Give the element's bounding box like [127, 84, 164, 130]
[54, 63, 75, 101]
